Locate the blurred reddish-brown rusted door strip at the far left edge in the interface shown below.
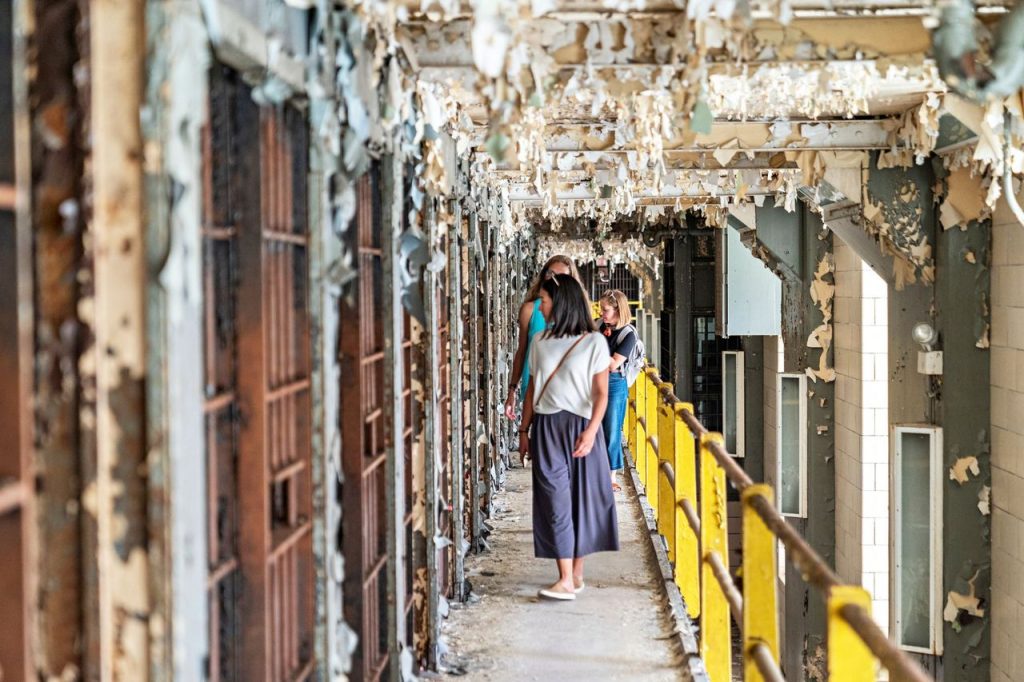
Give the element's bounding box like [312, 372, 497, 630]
[0, 2, 35, 667]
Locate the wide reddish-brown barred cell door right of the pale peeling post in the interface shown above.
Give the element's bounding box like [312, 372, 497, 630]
[204, 69, 314, 680]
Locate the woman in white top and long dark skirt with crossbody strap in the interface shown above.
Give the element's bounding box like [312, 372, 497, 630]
[519, 274, 618, 600]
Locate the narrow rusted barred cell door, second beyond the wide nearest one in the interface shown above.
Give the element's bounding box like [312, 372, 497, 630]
[341, 164, 393, 680]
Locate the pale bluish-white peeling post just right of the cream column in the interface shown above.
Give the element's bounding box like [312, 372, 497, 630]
[142, 3, 209, 680]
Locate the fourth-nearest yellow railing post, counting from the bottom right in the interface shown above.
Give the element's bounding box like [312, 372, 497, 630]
[672, 402, 700, 619]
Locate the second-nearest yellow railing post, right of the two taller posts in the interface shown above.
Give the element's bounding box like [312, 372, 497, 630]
[740, 483, 778, 682]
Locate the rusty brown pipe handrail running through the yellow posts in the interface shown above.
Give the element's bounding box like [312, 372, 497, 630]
[638, 366, 931, 682]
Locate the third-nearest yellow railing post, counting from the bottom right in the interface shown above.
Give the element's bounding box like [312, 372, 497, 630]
[700, 433, 732, 682]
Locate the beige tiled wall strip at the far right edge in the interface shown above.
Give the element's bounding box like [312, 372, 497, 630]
[990, 191, 1024, 682]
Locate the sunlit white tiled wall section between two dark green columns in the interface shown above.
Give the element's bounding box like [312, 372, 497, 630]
[834, 240, 889, 629]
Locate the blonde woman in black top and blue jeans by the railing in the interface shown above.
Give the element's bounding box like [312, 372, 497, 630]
[599, 289, 639, 493]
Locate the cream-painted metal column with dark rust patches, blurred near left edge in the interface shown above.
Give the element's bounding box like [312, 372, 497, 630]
[85, 0, 150, 667]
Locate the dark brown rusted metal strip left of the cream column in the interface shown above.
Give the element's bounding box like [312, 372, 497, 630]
[29, 0, 94, 678]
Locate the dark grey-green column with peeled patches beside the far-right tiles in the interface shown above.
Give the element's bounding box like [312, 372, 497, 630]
[933, 202, 993, 680]
